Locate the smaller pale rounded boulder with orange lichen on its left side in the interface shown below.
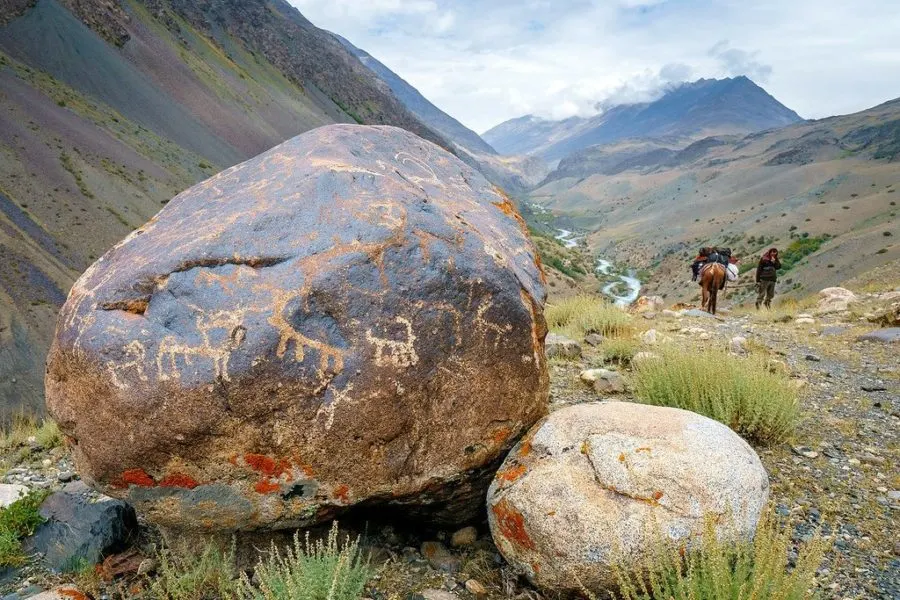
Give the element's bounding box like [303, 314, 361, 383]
[488, 402, 769, 592]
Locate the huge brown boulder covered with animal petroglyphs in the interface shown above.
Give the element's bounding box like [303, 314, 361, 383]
[46, 125, 548, 531]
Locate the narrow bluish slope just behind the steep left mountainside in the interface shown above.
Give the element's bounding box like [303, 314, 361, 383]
[333, 34, 497, 154]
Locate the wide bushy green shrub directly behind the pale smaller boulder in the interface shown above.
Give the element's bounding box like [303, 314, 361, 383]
[635, 349, 798, 443]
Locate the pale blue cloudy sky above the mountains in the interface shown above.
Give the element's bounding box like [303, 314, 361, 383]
[289, 0, 900, 133]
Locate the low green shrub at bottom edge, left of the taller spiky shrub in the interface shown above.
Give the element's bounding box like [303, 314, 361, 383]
[149, 544, 239, 600]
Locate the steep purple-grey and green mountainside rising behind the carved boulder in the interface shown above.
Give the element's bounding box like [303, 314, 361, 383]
[0, 0, 458, 420]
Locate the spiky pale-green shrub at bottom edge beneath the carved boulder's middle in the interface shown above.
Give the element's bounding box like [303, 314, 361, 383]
[240, 522, 372, 600]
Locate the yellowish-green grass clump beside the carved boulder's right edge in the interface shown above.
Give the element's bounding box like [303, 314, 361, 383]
[544, 296, 631, 339]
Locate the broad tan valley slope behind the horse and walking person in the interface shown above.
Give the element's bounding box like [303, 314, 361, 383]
[531, 100, 900, 301]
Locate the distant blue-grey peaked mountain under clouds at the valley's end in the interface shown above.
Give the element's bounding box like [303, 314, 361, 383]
[483, 76, 801, 161]
